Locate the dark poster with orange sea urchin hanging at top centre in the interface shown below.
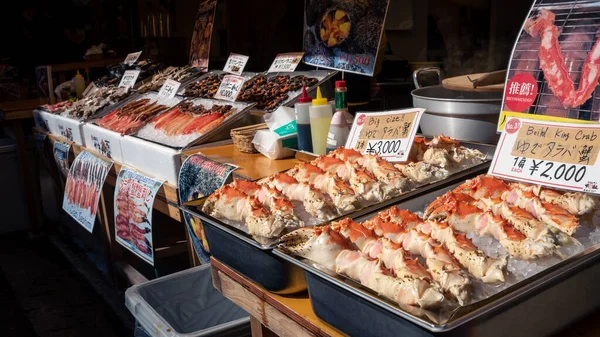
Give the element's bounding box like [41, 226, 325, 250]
[304, 0, 389, 76]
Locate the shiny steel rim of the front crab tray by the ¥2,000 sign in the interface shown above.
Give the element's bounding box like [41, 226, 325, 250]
[273, 183, 600, 336]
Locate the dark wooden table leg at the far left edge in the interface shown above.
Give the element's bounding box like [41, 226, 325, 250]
[10, 119, 42, 234]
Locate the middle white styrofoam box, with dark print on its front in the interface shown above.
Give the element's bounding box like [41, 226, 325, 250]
[83, 123, 123, 163]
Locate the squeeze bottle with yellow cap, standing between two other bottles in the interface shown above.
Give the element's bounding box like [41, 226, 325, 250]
[308, 87, 333, 155]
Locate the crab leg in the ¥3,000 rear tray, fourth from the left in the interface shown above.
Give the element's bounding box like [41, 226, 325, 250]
[288, 163, 359, 213]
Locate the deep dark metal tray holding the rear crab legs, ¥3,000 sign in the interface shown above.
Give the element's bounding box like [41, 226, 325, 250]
[180, 138, 495, 293]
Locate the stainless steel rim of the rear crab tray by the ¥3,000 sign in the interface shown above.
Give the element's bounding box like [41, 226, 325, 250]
[183, 142, 495, 250]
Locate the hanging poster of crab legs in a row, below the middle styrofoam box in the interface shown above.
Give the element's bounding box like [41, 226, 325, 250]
[63, 151, 112, 233]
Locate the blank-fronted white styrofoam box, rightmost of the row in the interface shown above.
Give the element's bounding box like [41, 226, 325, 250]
[121, 136, 181, 186]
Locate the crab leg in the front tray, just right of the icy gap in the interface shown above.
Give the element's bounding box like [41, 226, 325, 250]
[425, 192, 555, 260]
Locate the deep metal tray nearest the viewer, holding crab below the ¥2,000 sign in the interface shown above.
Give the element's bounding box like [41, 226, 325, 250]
[273, 183, 600, 336]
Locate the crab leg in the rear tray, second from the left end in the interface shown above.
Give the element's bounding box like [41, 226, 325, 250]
[230, 179, 304, 228]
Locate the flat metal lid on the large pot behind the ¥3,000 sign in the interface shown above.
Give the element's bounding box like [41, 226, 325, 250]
[411, 85, 502, 104]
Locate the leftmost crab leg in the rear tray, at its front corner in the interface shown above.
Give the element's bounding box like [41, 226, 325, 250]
[202, 185, 285, 237]
